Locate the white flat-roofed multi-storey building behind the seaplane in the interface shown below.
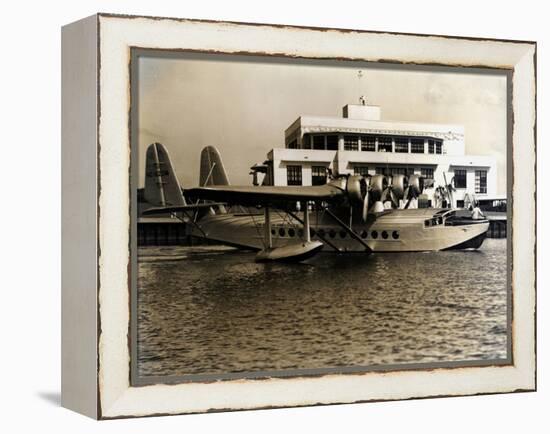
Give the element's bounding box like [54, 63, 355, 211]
[268, 104, 497, 207]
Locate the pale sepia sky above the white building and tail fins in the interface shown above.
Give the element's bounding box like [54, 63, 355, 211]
[136, 53, 507, 194]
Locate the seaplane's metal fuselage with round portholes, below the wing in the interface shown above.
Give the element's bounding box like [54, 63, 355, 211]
[193, 208, 489, 252]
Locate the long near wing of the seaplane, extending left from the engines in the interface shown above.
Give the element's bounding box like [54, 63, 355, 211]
[185, 184, 345, 206]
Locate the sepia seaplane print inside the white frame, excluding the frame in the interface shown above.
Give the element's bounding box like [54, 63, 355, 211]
[130, 49, 512, 384]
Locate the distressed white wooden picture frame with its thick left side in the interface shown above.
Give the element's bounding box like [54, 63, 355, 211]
[62, 14, 536, 419]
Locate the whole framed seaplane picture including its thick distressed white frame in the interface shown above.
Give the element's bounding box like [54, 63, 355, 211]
[56, 13, 537, 420]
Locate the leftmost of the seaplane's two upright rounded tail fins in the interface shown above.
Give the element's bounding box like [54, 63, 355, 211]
[144, 143, 186, 207]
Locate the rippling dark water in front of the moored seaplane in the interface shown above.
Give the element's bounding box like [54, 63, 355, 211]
[138, 239, 507, 377]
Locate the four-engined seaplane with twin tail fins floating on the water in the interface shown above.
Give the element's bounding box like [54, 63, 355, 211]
[143, 143, 489, 262]
